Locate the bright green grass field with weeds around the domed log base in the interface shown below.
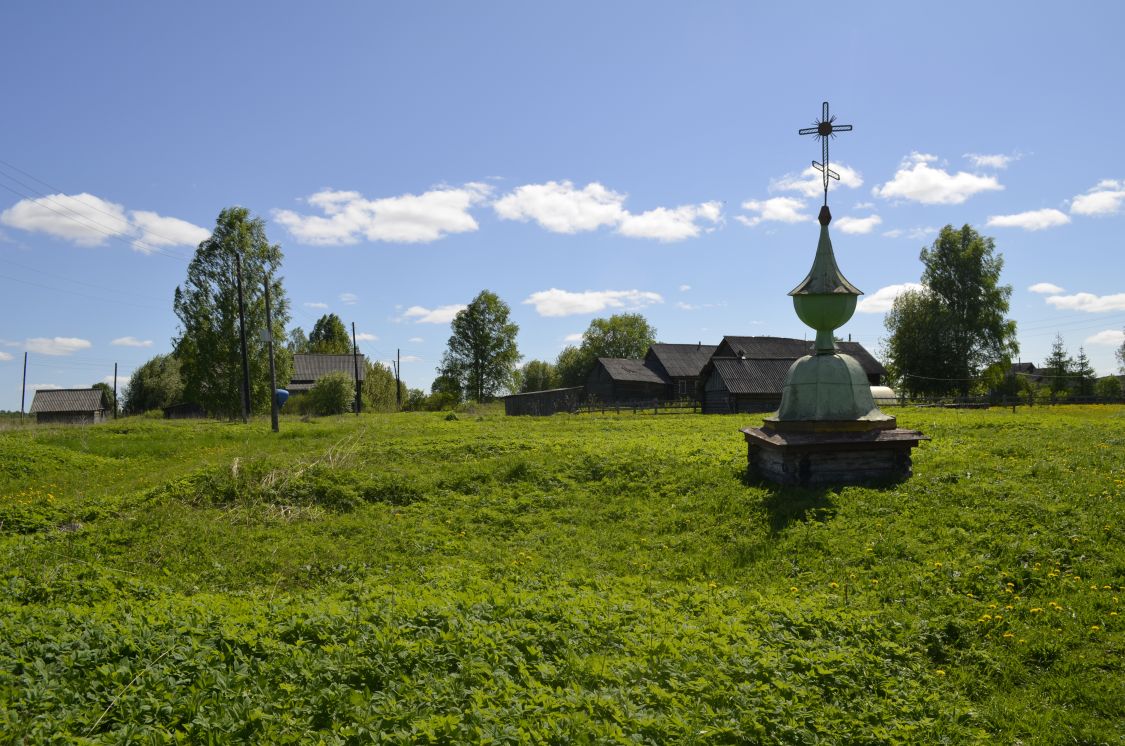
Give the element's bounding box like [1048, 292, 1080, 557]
[0, 406, 1125, 744]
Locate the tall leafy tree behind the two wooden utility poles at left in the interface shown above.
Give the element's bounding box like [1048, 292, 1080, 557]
[173, 207, 293, 417]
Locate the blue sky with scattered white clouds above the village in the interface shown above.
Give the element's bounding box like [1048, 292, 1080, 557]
[0, 2, 1125, 410]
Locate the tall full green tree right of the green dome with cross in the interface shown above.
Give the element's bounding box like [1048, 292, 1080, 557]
[885, 225, 1019, 394]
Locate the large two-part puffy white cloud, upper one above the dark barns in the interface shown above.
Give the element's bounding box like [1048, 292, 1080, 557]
[493, 181, 722, 241]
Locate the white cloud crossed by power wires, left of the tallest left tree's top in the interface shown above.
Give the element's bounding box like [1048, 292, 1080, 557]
[0, 192, 210, 253]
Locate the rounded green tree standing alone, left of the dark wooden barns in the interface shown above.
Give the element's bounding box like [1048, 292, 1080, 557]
[441, 290, 520, 402]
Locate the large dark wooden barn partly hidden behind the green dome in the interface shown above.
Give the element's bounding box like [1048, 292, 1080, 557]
[703, 336, 887, 414]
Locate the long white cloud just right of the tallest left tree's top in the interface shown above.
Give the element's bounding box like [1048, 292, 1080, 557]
[273, 182, 492, 245]
